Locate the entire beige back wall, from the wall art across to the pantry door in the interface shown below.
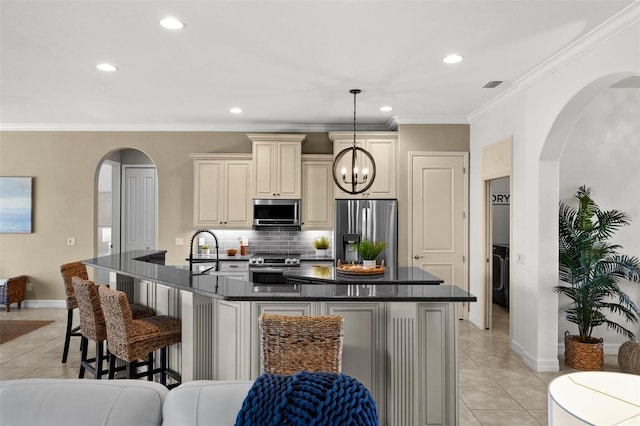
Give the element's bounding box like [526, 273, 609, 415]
[0, 125, 469, 300]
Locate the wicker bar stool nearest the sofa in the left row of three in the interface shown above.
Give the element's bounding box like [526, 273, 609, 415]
[98, 286, 182, 385]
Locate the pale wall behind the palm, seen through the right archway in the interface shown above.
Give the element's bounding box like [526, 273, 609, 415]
[558, 88, 640, 353]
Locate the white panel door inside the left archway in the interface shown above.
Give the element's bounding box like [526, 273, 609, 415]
[122, 167, 156, 251]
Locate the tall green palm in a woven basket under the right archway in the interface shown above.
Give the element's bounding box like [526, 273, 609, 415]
[554, 186, 640, 370]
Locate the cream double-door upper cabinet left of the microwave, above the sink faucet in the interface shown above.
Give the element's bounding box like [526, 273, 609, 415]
[191, 154, 253, 229]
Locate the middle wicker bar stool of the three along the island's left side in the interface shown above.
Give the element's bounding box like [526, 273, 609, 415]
[71, 277, 108, 379]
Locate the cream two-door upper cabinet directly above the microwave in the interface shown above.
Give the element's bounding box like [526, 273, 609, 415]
[247, 134, 306, 198]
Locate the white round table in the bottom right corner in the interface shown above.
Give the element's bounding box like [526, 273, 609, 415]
[548, 371, 640, 426]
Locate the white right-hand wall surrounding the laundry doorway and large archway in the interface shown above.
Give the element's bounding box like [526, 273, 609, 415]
[470, 3, 640, 371]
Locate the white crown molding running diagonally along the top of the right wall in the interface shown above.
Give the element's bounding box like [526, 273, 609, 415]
[467, 0, 640, 122]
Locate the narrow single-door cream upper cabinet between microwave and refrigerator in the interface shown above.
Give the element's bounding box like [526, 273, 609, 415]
[302, 154, 335, 230]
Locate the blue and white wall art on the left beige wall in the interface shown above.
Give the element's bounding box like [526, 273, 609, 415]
[0, 176, 33, 234]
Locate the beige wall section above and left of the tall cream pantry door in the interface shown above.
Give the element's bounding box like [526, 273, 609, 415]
[398, 124, 469, 266]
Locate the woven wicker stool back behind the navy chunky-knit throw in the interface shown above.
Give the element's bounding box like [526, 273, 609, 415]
[259, 314, 344, 375]
